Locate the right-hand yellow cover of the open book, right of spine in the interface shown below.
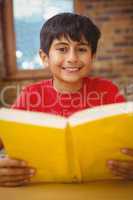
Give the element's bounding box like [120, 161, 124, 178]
[71, 114, 133, 181]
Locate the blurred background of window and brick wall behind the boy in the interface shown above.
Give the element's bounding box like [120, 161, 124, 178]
[0, 0, 133, 107]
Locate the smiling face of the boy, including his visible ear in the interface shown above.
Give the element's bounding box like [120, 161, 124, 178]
[40, 37, 93, 84]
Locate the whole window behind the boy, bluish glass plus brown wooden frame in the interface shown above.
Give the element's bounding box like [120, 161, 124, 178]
[2, 0, 83, 79]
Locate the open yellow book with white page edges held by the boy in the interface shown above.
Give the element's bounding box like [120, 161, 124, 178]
[0, 102, 133, 182]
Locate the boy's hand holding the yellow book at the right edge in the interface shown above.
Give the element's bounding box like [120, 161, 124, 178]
[108, 148, 133, 180]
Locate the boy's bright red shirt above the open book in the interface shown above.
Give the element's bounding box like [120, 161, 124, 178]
[12, 77, 125, 117]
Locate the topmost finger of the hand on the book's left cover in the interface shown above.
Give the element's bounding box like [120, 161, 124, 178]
[0, 157, 27, 168]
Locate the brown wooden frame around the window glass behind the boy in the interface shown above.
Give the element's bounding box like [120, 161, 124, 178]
[0, 0, 83, 80]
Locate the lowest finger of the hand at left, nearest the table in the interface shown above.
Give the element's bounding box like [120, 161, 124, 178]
[0, 179, 30, 187]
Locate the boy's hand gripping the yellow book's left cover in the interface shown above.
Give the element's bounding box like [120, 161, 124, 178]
[0, 157, 35, 187]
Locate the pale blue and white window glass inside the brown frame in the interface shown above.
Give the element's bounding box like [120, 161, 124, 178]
[13, 0, 73, 70]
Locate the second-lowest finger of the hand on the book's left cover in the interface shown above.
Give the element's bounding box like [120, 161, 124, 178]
[0, 174, 33, 183]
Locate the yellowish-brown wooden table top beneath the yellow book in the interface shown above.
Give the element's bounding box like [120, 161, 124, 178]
[0, 181, 133, 200]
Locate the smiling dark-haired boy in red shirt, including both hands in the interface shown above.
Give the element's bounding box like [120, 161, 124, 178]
[0, 13, 133, 186]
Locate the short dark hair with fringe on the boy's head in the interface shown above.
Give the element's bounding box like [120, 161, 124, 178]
[40, 13, 101, 54]
